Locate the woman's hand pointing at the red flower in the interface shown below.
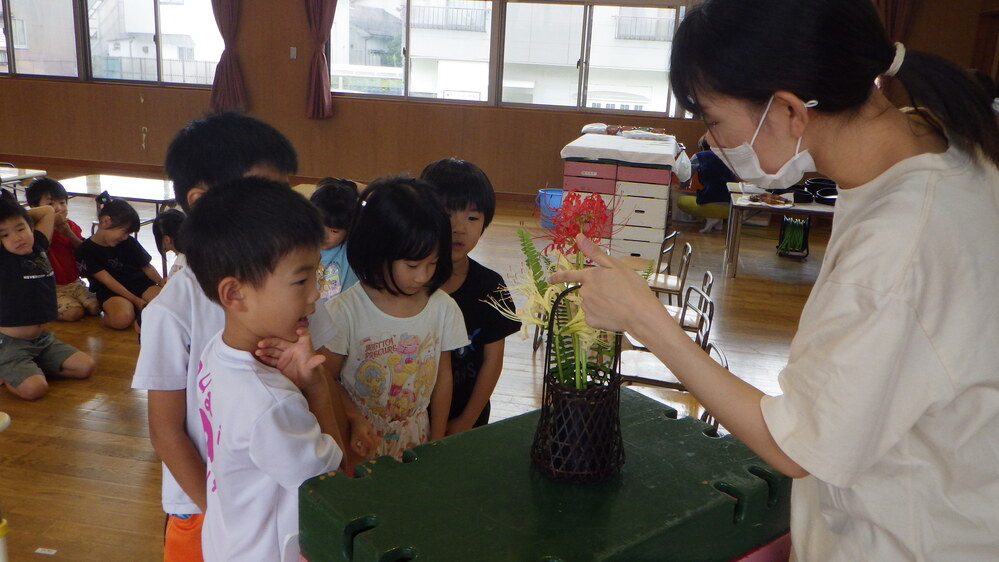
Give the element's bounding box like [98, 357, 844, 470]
[548, 234, 662, 332]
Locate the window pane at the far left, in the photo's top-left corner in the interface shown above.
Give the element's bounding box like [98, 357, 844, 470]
[9, 0, 78, 76]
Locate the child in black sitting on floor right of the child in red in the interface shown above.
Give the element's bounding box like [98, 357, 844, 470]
[76, 199, 163, 330]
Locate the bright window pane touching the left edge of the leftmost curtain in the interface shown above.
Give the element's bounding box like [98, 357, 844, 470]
[158, 0, 225, 84]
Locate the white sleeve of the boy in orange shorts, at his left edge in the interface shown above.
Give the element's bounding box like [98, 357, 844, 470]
[132, 300, 191, 390]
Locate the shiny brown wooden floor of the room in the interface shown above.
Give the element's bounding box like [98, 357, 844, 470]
[0, 183, 828, 561]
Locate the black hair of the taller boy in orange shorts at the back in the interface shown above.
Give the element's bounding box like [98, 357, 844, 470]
[164, 112, 298, 211]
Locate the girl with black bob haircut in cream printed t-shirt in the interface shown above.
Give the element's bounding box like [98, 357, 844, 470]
[325, 177, 468, 466]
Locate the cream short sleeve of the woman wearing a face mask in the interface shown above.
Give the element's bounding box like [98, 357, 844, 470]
[761, 282, 954, 486]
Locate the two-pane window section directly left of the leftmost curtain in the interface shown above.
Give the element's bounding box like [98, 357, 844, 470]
[87, 0, 224, 84]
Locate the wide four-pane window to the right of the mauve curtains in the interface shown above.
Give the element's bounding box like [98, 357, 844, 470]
[330, 0, 685, 116]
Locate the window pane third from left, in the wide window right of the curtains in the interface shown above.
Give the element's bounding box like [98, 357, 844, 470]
[502, 2, 583, 106]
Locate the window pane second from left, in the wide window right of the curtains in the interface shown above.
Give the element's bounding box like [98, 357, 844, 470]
[409, 0, 492, 101]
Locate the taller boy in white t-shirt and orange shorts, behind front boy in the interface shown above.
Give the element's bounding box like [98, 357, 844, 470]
[132, 113, 334, 562]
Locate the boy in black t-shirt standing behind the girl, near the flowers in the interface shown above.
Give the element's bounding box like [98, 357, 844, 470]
[420, 158, 520, 435]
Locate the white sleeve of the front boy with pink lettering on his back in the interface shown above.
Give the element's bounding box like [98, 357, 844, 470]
[249, 393, 343, 489]
